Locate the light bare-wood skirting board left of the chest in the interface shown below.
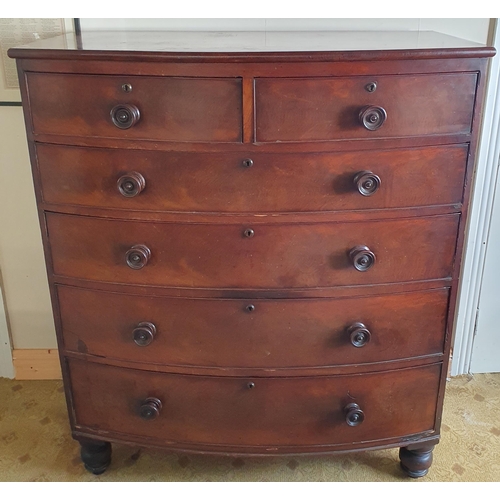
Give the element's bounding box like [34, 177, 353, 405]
[12, 349, 62, 380]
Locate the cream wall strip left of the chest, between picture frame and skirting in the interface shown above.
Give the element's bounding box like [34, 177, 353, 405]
[0, 106, 57, 349]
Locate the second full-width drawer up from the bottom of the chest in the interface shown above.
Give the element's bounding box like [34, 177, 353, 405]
[57, 286, 448, 369]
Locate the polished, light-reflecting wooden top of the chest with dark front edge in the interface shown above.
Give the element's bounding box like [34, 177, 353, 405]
[9, 31, 495, 61]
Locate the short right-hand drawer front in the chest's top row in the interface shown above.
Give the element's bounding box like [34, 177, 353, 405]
[255, 73, 477, 142]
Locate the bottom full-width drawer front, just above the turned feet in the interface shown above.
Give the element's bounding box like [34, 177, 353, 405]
[69, 360, 441, 448]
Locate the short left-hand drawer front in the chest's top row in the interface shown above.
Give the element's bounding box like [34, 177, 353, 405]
[27, 73, 242, 142]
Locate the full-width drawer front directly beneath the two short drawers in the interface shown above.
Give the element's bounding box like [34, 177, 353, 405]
[37, 144, 468, 212]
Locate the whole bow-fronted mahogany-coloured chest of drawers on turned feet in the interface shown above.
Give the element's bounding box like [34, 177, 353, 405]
[10, 33, 494, 477]
